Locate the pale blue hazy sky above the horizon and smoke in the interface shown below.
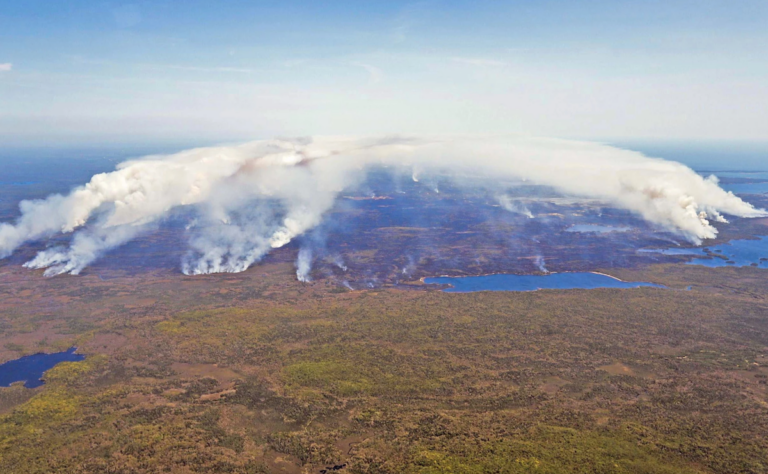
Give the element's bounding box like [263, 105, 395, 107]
[0, 0, 768, 144]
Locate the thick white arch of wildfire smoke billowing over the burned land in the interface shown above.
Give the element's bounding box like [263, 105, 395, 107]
[0, 137, 768, 275]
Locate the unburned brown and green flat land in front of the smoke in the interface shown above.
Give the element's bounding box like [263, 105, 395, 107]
[0, 262, 768, 474]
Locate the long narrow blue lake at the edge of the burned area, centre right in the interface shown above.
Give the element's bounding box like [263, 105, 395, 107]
[424, 272, 664, 293]
